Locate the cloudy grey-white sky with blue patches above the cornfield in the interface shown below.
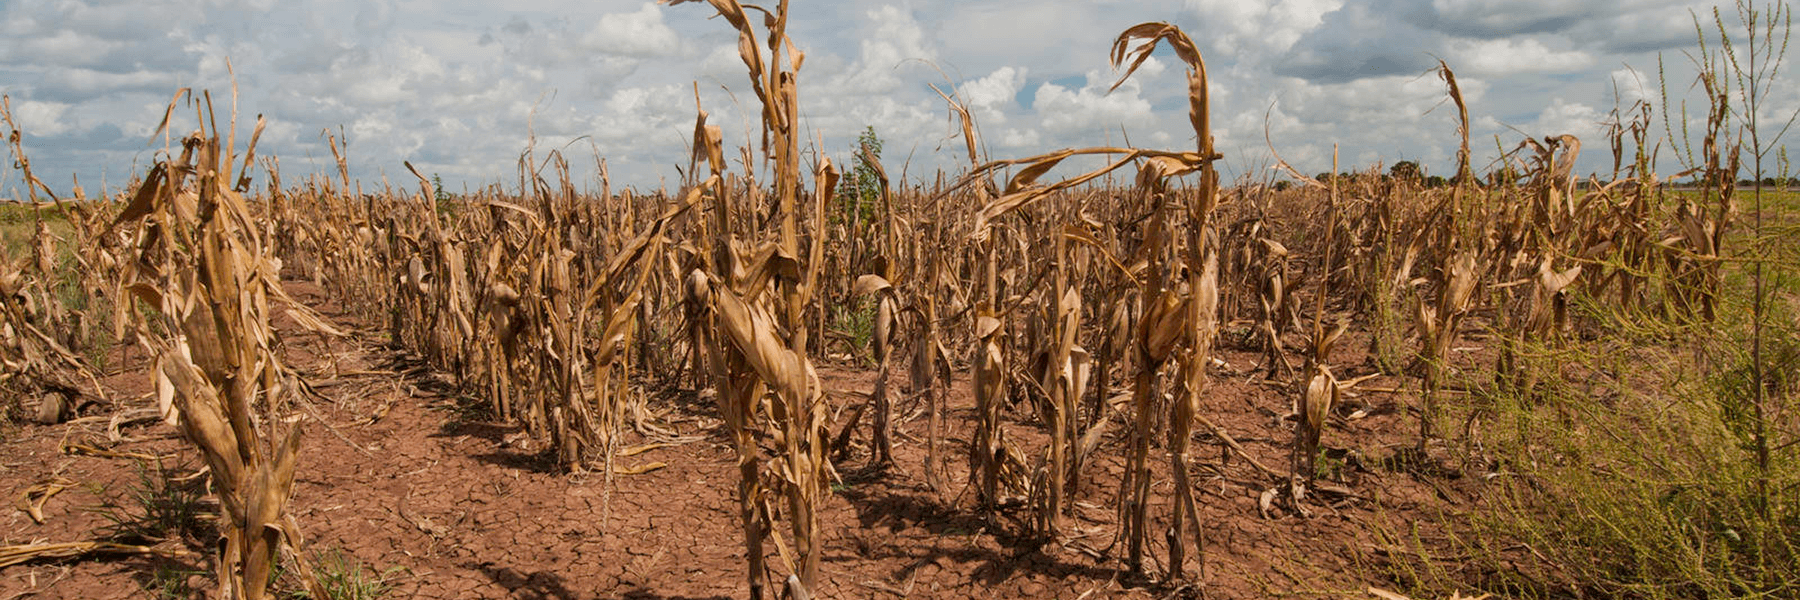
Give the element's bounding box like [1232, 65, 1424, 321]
[0, 0, 1800, 198]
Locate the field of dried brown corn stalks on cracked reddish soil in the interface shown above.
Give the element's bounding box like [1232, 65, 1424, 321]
[0, 0, 1800, 598]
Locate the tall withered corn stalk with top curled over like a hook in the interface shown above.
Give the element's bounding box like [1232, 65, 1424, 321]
[928, 23, 1219, 571]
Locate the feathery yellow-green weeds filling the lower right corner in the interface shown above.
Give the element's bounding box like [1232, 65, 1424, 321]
[1381, 263, 1800, 598]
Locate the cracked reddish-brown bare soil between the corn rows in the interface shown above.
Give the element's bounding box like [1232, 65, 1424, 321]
[0, 283, 1467, 600]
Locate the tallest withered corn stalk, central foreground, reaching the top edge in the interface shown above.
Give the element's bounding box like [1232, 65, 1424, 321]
[666, 0, 837, 598]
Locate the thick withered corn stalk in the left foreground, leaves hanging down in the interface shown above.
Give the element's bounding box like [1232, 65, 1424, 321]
[115, 95, 340, 600]
